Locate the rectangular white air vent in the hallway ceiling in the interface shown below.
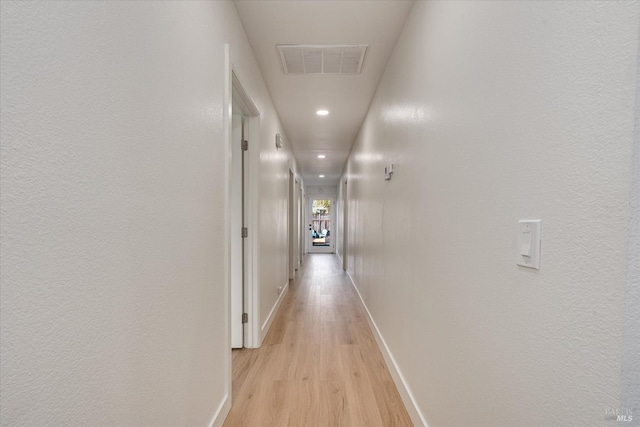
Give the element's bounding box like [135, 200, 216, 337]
[276, 44, 368, 74]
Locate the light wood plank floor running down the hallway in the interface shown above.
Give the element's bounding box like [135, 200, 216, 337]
[224, 254, 412, 427]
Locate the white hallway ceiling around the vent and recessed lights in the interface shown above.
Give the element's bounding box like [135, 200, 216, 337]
[235, 0, 413, 185]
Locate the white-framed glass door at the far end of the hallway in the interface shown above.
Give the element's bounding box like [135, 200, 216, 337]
[307, 196, 335, 253]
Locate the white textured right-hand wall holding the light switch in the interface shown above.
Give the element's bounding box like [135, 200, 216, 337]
[345, 1, 640, 426]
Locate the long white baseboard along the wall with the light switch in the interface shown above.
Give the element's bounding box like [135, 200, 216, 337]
[347, 271, 428, 427]
